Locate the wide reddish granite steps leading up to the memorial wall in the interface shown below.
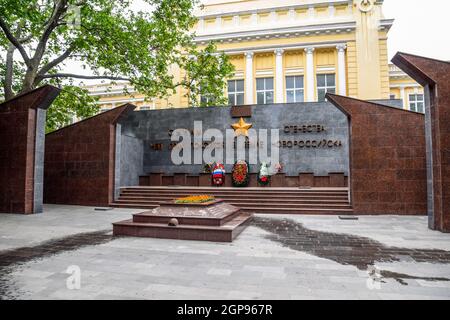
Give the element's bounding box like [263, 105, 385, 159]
[111, 186, 353, 215]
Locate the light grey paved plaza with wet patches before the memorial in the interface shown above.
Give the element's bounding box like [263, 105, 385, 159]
[0, 205, 450, 300]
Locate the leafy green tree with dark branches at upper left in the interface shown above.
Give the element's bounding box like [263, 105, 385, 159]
[0, 0, 233, 130]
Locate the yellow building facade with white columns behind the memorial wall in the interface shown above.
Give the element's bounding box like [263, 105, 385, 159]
[88, 0, 423, 111]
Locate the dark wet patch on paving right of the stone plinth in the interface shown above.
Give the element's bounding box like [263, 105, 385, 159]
[252, 217, 450, 285]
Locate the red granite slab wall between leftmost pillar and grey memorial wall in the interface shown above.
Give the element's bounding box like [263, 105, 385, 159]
[44, 104, 135, 206]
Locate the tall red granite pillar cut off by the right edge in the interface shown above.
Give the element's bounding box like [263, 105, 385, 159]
[392, 52, 450, 232]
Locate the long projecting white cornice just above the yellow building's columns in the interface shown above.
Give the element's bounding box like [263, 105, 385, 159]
[195, 21, 356, 44]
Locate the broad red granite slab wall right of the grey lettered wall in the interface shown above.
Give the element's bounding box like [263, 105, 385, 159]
[327, 94, 427, 215]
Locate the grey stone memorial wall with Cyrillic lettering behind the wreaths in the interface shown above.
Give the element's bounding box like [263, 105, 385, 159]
[120, 102, 349, 179]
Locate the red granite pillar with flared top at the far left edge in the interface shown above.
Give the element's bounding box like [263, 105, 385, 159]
[0, 85, 60, 214]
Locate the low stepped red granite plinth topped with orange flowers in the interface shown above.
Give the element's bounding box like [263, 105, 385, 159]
[113, 200, 252, 242]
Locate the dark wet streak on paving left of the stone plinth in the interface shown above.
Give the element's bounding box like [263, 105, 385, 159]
[0, 230, 113, 300]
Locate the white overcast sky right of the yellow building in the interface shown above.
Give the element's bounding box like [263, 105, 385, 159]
[383, 0, 450, 61]
